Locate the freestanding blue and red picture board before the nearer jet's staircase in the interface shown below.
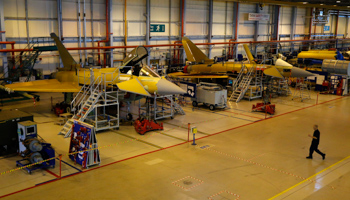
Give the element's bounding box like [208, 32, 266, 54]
[69, 120, 101, 168]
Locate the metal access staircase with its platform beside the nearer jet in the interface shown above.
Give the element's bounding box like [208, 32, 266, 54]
[59, 71, 119, 137]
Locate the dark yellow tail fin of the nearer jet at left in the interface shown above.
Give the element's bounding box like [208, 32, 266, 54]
[50, 33, 80, 71]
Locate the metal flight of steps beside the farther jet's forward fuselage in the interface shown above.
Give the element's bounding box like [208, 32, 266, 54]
[229, 65, 255, 103]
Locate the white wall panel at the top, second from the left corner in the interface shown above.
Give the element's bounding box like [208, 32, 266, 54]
[28, 0, 57, 18]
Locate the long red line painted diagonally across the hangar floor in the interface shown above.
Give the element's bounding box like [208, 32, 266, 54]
[0, 97, 343, 199]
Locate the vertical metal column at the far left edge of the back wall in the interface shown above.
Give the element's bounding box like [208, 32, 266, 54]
[0, 0, 8, 78]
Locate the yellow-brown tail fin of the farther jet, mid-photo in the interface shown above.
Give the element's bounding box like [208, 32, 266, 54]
[182, 37, 210, 63]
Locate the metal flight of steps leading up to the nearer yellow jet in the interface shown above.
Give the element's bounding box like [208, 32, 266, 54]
[58, 77, 102, 138]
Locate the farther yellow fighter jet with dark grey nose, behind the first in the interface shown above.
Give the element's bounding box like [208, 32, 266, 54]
[169, 37, 313, 78]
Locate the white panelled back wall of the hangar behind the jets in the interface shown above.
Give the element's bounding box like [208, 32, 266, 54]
[3, 0, 350, 74]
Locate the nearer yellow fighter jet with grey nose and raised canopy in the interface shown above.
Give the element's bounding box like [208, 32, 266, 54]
[1, 33, 185, 101]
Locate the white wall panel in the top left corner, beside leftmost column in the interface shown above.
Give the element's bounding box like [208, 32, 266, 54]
[3, 0, 26, 17]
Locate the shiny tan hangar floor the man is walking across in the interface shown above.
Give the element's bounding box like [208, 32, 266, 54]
[0, 89, 350, 200]
